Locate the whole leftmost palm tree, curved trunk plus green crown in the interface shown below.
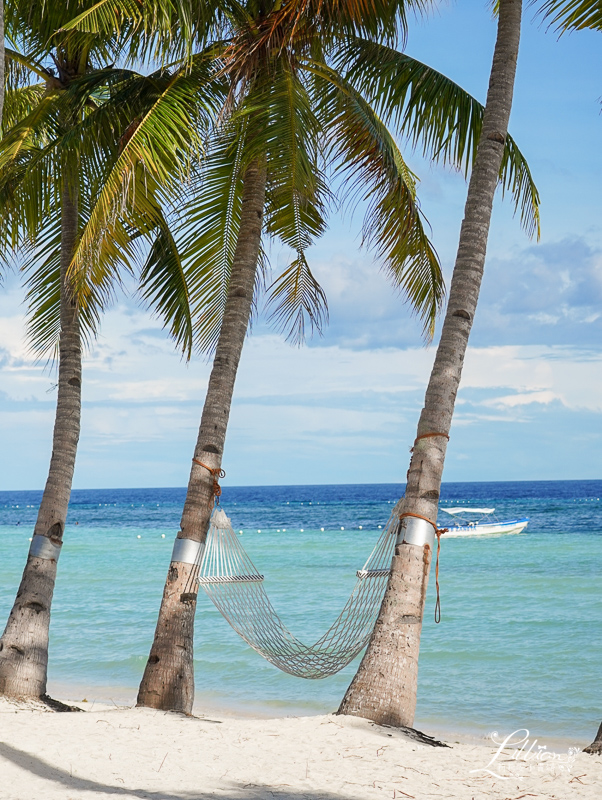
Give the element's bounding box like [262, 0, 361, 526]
[0, 2, 209, 697]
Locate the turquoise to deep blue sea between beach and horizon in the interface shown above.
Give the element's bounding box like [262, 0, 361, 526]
[0, 481, 602, 744]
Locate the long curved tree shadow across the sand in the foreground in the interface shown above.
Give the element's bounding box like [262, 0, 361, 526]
[0, 742, 366, 800]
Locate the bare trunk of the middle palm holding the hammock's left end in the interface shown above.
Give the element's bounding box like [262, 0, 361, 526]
[137, 162, 266, 713]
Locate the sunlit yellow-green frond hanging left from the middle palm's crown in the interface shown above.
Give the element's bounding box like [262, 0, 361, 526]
[72, 56, 222, 304]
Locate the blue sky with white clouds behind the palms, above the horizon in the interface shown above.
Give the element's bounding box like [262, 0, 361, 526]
[0, 0, 602, 490]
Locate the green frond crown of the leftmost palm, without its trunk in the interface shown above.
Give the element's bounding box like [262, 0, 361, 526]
[0, 0, 224, 353]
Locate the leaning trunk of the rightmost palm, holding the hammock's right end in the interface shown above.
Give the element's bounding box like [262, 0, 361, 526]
[338, 0, 521, 726]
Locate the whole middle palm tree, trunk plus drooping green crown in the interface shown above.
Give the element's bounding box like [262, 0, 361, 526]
[116, 3, 537, 712]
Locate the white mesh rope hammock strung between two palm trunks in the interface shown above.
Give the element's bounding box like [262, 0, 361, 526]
[186, 506, 399, 678]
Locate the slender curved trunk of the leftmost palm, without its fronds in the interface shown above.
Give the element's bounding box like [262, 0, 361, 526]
[0, 172, 82, 697]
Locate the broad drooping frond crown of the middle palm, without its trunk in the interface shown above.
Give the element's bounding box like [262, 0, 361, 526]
[54, 0, 538, 351]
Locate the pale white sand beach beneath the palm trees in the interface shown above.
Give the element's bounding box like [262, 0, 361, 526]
[0, 700, 602, 800]
